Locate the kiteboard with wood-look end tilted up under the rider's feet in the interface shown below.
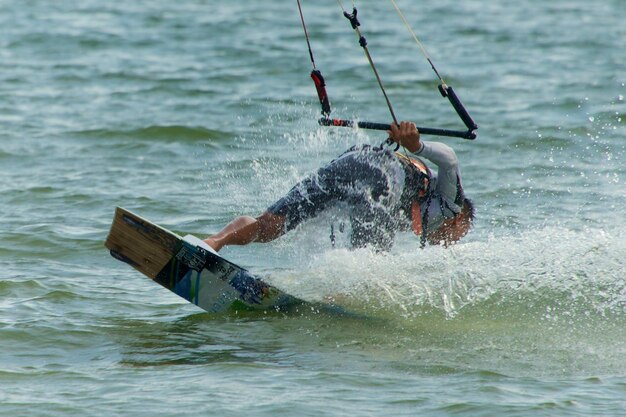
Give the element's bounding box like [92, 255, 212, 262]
[105, 207, 303, 313]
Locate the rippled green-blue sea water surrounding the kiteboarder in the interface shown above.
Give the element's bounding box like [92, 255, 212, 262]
[0, 0, 626, 416]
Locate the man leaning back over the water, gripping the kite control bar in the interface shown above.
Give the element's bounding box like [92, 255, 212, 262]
[205, 122, 474, 251]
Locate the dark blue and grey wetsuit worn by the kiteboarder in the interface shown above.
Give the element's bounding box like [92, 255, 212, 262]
[268, 142, 463, 249]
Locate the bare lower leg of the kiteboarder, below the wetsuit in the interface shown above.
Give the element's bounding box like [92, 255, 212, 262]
[204, 211, 285, 251]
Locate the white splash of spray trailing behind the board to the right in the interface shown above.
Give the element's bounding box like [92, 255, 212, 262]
[271, 224, 626, 318]
